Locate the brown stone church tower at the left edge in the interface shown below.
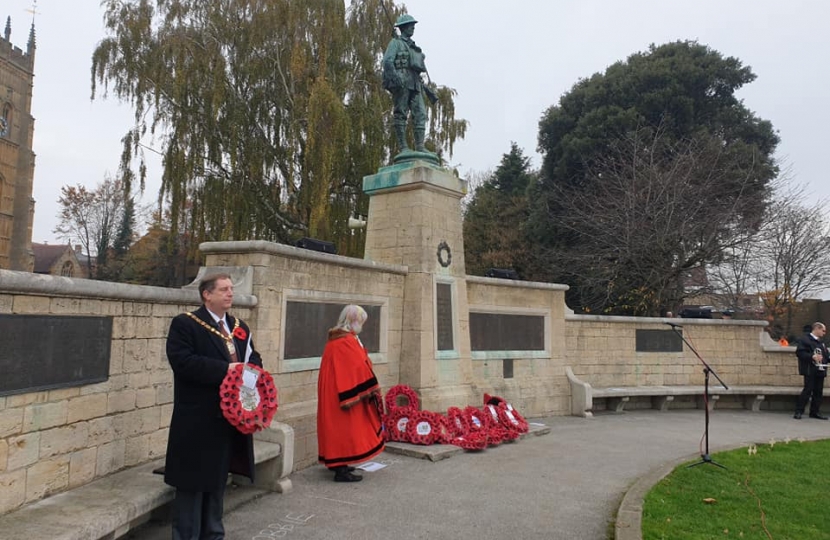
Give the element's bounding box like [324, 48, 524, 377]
[0, 17, 35, 272]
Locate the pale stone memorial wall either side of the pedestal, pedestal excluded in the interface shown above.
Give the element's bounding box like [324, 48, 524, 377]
[0, 242, 799, 513]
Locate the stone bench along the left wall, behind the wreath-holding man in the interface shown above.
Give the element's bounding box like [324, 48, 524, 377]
[0, 422, 294, 540]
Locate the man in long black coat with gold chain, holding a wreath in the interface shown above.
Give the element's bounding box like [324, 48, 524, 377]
[164, 274, 262, 540]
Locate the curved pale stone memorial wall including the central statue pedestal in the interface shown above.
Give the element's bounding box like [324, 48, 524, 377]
[0, 159, 800, 514]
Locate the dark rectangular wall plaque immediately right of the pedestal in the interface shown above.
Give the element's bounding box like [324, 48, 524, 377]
[470, 313, 545, 351]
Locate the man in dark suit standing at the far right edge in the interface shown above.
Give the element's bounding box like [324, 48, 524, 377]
[793, 322, 830, 420]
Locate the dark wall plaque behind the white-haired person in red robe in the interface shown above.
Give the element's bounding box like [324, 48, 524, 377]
[285, 302, 380, 360]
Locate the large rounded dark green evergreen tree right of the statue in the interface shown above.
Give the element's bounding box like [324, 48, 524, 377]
[526, 41, 779, 315]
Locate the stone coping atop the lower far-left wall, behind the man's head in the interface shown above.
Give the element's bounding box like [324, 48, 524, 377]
[0, 270, 257, 308]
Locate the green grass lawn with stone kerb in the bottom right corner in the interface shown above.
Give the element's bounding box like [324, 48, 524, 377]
[643, 440, 830, 540]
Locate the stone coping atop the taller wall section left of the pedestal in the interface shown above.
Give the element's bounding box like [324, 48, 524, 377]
[199, 240, 409, 275]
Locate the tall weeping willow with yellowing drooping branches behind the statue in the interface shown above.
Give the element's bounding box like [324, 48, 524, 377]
[92, 0, 467, 254]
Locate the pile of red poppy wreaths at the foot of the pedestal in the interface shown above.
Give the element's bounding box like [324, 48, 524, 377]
[382, 384, 529, 450]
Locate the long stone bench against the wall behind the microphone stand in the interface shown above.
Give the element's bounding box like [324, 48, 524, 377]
[565, 366, 801, 418]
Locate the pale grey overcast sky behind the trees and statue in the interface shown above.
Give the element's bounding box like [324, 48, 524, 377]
[6, 0, 830, 247]
